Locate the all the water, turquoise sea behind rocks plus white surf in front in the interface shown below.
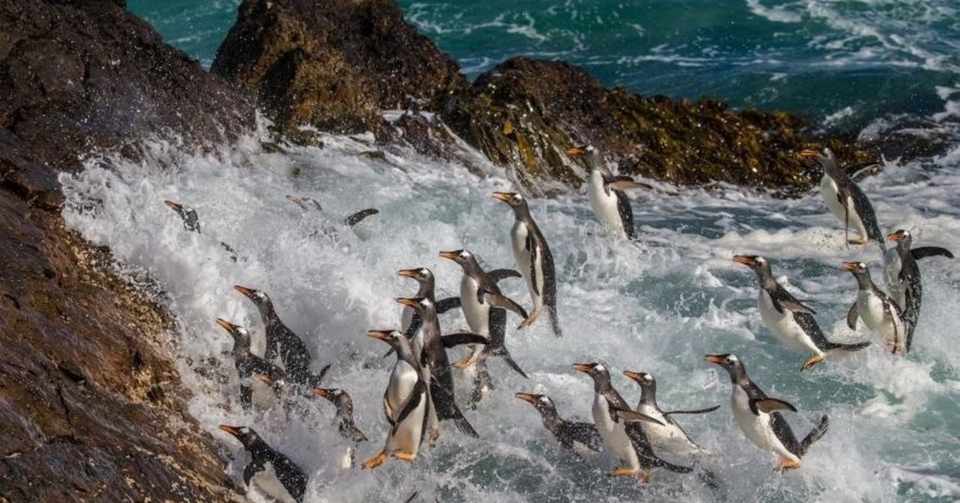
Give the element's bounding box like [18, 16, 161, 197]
[61, 0, 960, 503]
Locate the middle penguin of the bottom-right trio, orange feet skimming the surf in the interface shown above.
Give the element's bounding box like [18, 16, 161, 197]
[573, 363, 693, 483]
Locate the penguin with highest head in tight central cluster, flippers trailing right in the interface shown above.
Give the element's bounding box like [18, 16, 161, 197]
[440, 250, 527, 378]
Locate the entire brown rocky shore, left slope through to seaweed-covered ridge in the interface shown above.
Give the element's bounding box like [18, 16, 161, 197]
[0, 0, 912, 502]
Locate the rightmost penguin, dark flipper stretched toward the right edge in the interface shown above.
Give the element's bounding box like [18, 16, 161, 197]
[883, 229, 953, 342]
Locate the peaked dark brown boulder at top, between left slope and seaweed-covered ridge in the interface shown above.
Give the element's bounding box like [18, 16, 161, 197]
[212, 0, 467, 136]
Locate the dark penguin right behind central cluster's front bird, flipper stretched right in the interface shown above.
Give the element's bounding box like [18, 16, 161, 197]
[397, 297, 487, 441]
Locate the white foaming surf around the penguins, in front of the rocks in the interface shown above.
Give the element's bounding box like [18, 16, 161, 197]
[61, 121, 960, 502]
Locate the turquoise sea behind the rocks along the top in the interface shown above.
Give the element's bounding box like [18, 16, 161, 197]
[129, 0, 960, 126]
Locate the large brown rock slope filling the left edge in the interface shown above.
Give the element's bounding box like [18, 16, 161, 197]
[0, 0, 254, 502]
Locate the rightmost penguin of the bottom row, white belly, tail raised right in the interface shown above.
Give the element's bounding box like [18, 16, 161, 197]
[706, 354, 828, 470]
